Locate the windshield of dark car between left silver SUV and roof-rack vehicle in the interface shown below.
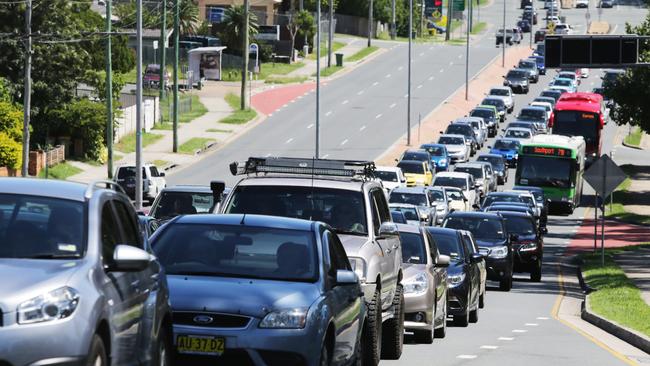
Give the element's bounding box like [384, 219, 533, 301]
[149, 192, 214, 219]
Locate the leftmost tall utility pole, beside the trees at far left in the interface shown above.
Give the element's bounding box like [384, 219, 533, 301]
[20, 0, 32, 177]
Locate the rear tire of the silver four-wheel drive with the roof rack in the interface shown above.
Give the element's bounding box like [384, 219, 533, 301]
[381, 285, 404, 360]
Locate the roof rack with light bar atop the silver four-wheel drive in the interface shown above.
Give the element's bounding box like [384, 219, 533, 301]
[230, 157, 375, 179]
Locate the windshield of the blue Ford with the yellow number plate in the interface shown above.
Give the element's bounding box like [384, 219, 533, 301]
[152, 224, 318, 282]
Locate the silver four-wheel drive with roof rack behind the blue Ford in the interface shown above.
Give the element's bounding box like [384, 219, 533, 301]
[212, 157, 404, 365]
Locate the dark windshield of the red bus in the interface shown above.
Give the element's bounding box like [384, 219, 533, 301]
[553, 111, 600, 146]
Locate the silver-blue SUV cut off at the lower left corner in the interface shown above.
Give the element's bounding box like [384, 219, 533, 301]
[0, 178, 172, 366]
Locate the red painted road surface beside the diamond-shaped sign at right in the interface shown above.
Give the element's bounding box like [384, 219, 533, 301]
[567, 219, 650, 254]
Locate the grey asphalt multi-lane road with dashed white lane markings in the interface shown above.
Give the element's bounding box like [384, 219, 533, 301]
[168, 1, 646, 366]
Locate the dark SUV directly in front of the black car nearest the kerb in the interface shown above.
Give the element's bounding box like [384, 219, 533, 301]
[442, 211, 516, 291]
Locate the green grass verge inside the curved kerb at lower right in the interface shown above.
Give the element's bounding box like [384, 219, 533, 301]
[581, 246, 650, 336]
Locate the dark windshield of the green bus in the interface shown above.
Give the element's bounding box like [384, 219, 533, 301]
[517, 155, 575, 188]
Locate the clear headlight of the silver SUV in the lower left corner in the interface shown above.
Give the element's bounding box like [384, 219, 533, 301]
[16, 286, 79, 324]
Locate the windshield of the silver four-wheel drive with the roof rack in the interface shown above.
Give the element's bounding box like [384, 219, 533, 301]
[224, 185, 368, 235]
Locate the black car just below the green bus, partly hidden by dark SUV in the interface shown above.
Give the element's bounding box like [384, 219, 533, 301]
[501, 211, 546, 282]
